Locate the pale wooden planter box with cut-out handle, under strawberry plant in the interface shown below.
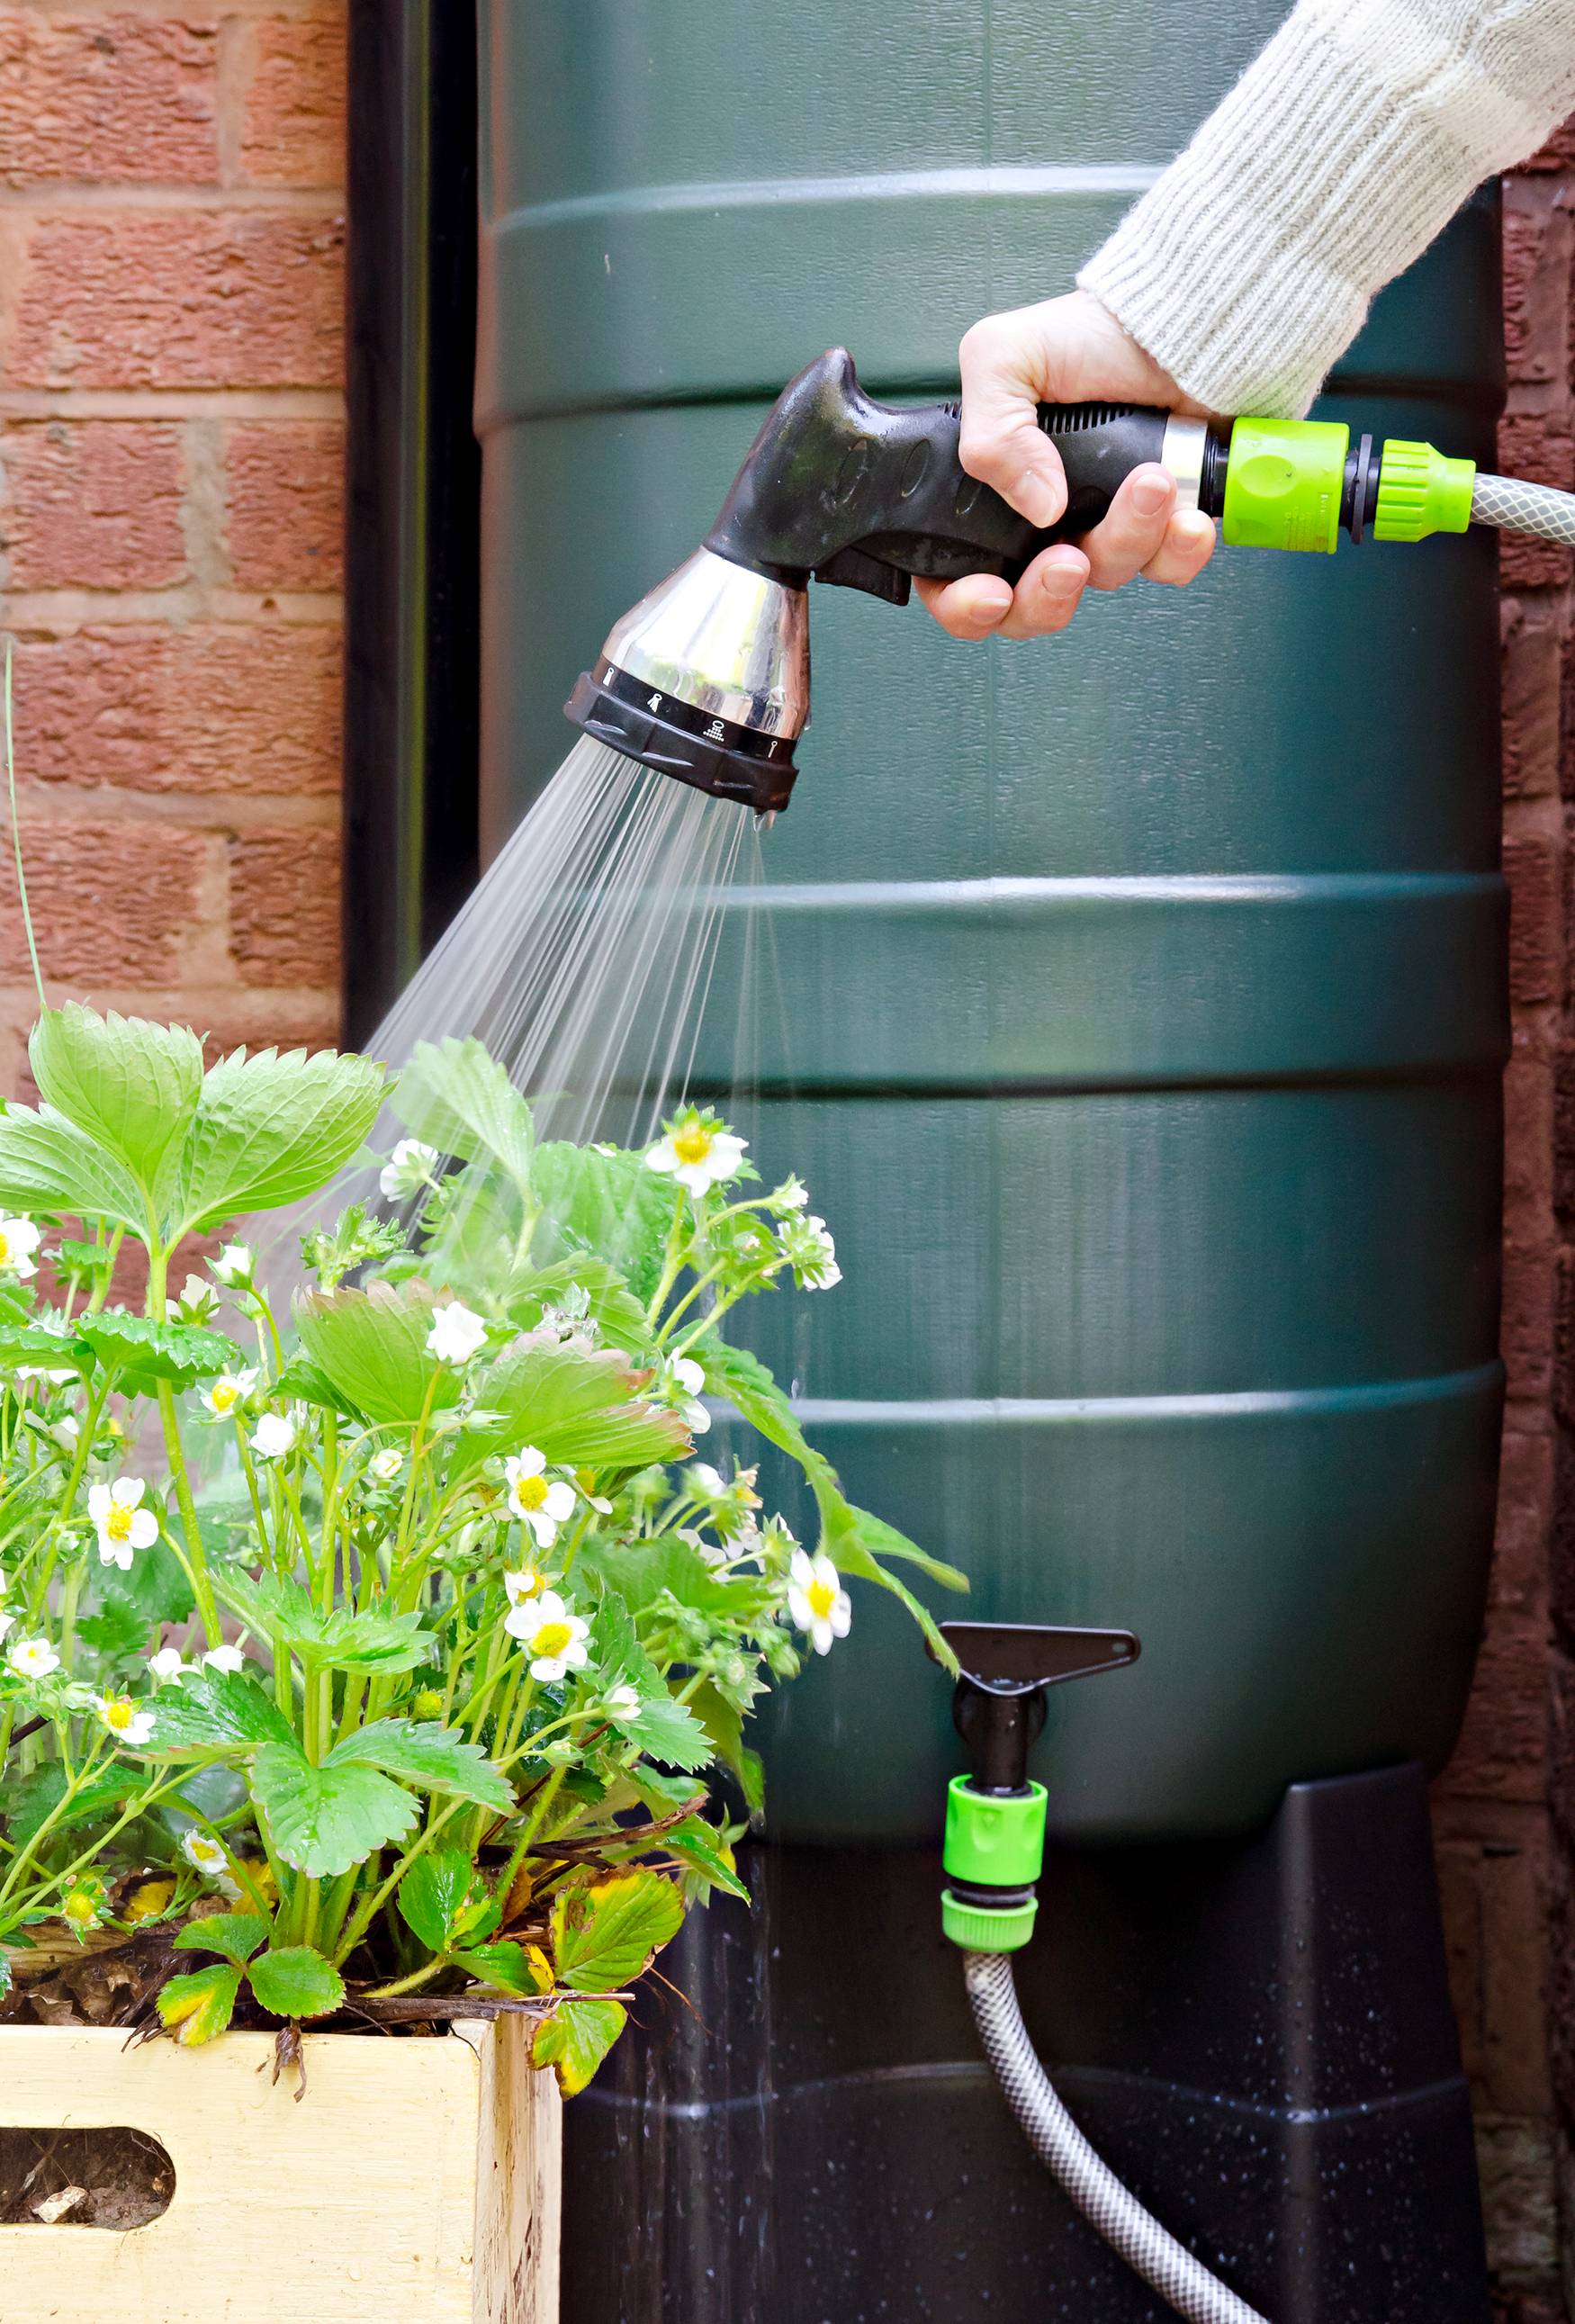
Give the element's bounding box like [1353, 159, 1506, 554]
[0, 2017, 560, 2324]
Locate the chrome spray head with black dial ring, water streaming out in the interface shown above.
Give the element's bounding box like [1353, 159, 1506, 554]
[567, 548, 808, 814]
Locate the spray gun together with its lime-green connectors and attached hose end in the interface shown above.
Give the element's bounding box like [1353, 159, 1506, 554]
[567, 347, 1575, 814]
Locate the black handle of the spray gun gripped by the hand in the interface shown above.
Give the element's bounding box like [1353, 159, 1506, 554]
[706, 347, 1198, 604]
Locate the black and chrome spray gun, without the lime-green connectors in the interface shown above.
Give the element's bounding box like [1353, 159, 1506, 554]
[567, 347, 1215, 814]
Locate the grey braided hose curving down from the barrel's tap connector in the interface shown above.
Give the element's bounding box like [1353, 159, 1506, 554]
[962, 1952, 1266, 2324]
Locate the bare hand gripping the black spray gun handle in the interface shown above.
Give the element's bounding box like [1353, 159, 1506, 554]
[915, 291, 1215, 636]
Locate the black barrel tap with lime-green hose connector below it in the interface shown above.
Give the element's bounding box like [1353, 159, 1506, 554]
[940, 1622, 1140, 1952]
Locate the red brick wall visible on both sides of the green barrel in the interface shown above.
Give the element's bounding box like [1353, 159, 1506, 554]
[0, 0, 1575, 2324]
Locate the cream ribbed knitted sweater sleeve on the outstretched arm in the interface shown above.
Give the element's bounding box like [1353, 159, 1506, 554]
[1078, 0, 1575, 416]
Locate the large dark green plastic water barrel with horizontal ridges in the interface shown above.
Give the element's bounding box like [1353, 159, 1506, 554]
[479, 0, 1506, 1843]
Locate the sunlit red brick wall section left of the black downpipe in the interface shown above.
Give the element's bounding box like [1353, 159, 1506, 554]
[0, 0, 344, 1085]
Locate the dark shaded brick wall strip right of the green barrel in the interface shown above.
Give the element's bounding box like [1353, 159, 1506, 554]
[1436, 125, 1575, 2324]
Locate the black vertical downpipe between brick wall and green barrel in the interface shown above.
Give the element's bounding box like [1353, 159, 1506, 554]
[344, 0, 481, 1041]
